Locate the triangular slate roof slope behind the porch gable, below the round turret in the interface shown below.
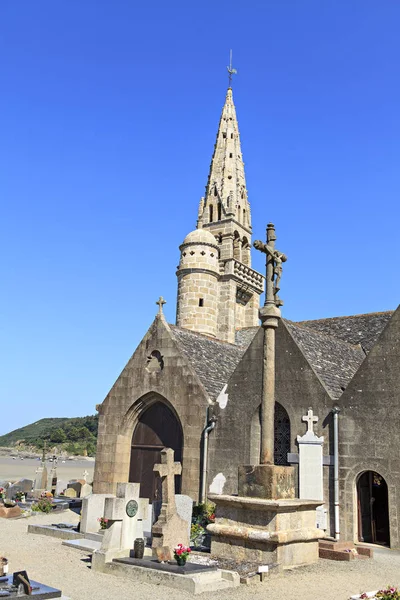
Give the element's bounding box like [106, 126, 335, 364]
[170, 325, 247, 400]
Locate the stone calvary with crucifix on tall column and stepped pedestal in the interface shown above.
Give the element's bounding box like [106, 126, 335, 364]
[207, 223, 323, 568]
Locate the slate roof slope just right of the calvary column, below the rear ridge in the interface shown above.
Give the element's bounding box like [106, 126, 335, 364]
[285, 319, 365, 399]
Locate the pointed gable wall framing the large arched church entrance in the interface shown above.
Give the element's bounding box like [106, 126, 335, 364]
[93, 317, 208, 500]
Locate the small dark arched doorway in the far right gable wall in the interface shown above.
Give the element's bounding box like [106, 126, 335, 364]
[357, 471, 390, 546]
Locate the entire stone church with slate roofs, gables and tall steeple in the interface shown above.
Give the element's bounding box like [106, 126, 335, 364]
[94, 88, 400, 547]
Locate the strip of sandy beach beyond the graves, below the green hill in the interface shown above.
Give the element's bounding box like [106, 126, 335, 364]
[0, 456, 94, 483]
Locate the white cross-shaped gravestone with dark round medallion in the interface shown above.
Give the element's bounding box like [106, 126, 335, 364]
[92, 483, 149, 571]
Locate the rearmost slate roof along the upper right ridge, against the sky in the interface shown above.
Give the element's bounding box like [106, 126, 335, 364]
[298, 311, 393, 353]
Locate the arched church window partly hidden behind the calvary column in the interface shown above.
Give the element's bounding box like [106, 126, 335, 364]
[250, 402, 291, 466]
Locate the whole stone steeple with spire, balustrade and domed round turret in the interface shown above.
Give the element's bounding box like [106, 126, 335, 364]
[177, 87, 264, 343]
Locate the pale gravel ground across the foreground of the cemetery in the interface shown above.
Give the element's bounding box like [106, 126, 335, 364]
[0, 511, 400, 600]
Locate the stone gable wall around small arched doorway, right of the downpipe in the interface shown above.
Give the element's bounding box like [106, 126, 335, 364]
[337, 308, 400, 548]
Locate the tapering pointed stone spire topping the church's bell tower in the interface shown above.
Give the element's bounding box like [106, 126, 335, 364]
[198, 87, 251, 229]
